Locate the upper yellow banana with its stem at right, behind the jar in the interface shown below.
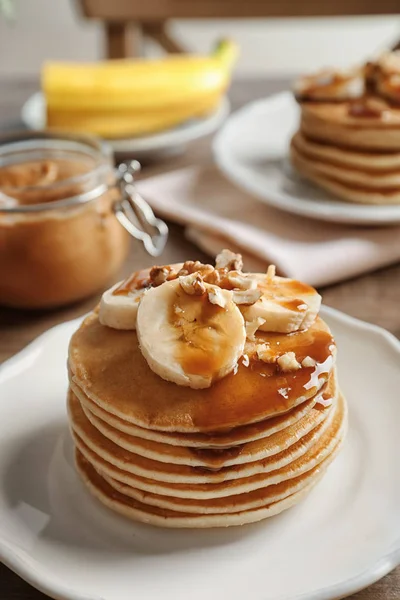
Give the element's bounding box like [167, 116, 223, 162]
[42, 40, 238, 111]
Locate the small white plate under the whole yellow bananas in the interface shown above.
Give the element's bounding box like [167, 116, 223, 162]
[21, 92, 230, 156]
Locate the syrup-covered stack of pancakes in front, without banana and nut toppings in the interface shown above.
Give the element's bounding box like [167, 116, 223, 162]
[68, 311, 346, 527]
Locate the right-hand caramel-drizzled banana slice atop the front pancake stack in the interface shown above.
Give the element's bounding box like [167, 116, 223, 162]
[240, 273, 321, 333]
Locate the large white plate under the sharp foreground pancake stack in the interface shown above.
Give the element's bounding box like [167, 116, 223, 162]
[0, 308, 400, 600]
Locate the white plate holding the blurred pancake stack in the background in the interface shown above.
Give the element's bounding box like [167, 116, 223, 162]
[213, 92, 400, 225]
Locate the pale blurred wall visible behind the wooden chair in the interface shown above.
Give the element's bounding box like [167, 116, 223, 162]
[0, 0, 400, 77]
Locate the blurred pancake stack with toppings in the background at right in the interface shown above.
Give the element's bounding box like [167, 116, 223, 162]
[290, 53, 400, 204]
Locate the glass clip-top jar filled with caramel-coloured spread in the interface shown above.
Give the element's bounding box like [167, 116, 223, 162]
[0, 132, 168, 308]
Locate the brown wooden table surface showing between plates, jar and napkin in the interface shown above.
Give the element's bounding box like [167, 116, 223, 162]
[0, 80, 400, 600]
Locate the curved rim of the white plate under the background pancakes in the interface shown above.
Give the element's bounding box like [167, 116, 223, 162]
[212, 90, 400, 226]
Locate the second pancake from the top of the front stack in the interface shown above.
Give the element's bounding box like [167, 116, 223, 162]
[70, 378, 330, 448]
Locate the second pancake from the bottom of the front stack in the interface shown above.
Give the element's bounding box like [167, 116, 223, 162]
[75, 397, 347, 499]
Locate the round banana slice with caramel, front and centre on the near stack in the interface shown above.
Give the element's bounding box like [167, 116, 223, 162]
[136, 278, 246, 389]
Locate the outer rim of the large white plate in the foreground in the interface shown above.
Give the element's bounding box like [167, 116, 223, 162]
[0, 305, 400, 600]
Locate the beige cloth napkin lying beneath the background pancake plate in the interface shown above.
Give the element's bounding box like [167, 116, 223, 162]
[138, 166, 400, 286]
